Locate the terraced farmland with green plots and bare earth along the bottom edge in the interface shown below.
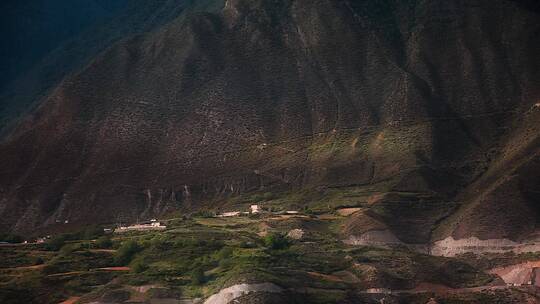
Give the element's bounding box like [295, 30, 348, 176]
[0, 209, 539, 304]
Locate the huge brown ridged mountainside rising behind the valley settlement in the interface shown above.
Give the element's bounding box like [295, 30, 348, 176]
[0, 0, 540, 241]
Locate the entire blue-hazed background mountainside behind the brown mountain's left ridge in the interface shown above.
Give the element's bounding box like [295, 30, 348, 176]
[0, 0, 221, 136]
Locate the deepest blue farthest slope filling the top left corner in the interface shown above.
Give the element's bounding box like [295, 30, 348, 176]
[0, 0, 125, 88]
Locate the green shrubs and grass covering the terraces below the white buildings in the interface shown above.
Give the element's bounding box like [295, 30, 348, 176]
[0, 198, 537, 304]
